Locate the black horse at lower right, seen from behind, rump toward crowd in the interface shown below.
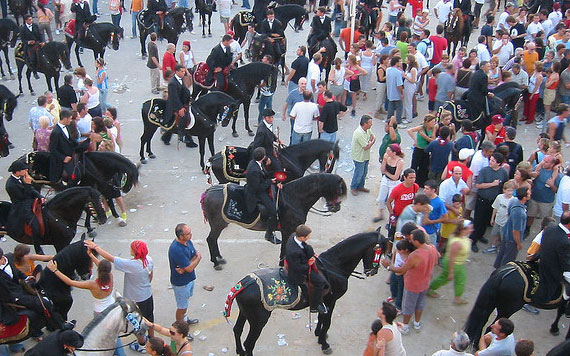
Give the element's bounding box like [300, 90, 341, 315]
[463, 263, 570, 347]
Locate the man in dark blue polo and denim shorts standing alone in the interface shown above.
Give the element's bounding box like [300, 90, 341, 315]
[168, 223, 202, 324]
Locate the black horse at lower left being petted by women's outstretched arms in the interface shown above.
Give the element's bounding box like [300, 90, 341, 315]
[38, 239, 94, 320]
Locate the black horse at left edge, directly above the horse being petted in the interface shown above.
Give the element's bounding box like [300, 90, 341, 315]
[0, 187, 107, 252]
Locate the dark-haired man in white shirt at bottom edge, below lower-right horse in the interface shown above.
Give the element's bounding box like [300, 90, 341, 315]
[475, 318, 515, 356]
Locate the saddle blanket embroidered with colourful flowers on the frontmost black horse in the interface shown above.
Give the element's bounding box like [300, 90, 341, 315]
[249, 268, 302, 311]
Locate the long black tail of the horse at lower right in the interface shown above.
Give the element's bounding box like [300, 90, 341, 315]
[463, 268, 504, 345]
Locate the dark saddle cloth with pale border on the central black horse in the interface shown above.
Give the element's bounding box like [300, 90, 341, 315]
[222, 183, 261, 228]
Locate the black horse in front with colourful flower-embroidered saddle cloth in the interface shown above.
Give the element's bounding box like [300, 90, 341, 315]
[224, 232, 388, 356]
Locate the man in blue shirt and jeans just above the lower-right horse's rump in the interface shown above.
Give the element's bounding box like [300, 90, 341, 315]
[493, 187, 530, 268]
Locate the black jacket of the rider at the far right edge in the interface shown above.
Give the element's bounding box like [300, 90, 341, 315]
[537, 226, 570, 302]
